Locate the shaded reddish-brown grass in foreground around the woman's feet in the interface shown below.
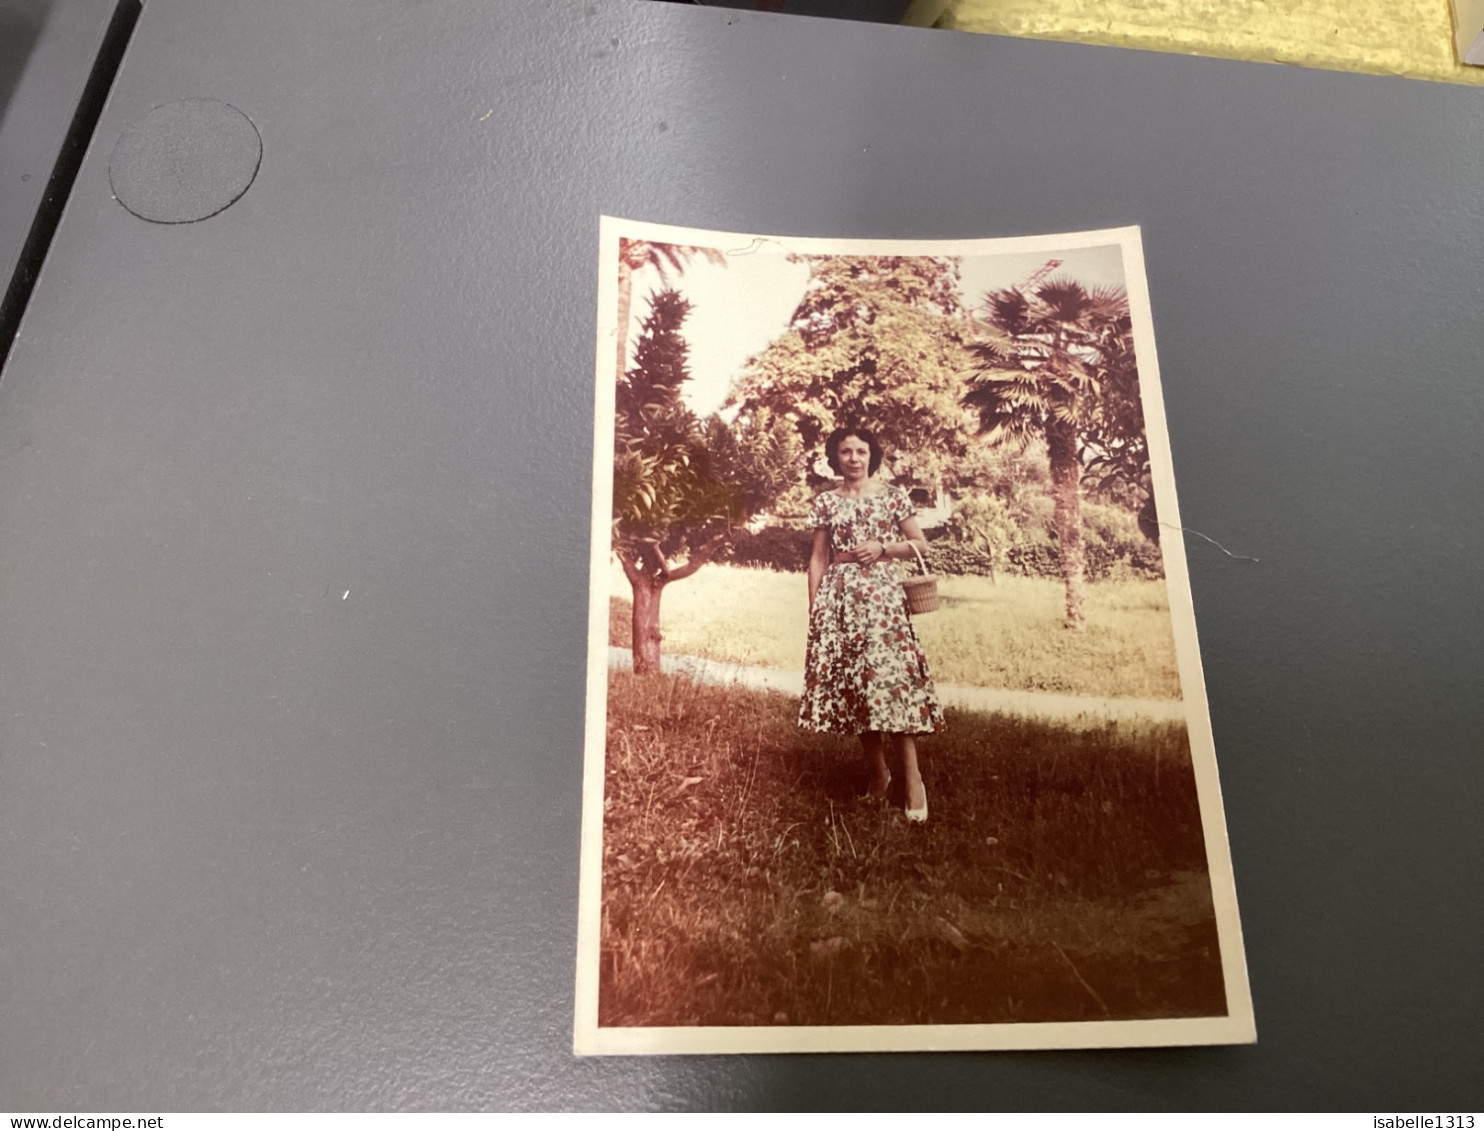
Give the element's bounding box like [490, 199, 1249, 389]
[600, 672, 1226, 1026]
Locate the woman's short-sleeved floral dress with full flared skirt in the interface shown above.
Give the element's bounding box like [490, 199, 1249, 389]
[798, 485, 942, 735]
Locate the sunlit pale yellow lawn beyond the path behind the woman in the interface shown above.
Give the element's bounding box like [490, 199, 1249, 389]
[610, 566, 1180, 699]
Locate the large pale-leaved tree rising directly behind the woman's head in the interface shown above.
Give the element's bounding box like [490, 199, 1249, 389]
[729, 255, 969, 481]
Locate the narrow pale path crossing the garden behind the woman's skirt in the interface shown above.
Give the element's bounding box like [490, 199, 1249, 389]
[608, 647, 1186, 724]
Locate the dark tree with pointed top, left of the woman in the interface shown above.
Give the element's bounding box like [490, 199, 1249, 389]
[613, 289, 746, 672]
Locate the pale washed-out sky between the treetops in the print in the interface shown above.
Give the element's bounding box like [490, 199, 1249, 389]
[629, 242, 1123, 417]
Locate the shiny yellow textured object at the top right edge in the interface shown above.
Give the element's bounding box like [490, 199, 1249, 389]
[938, 0, 1484, 85]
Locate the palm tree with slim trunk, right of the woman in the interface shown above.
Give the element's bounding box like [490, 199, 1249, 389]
[963, 278, 1149, 631]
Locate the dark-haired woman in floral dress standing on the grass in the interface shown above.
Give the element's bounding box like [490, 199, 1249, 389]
[798, 427, 942, 822]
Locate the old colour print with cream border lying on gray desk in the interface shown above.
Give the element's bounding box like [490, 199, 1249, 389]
[574, 218, 1254, 1054]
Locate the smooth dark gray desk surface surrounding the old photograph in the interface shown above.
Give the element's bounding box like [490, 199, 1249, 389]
[0, 0, 1484, 1110]
